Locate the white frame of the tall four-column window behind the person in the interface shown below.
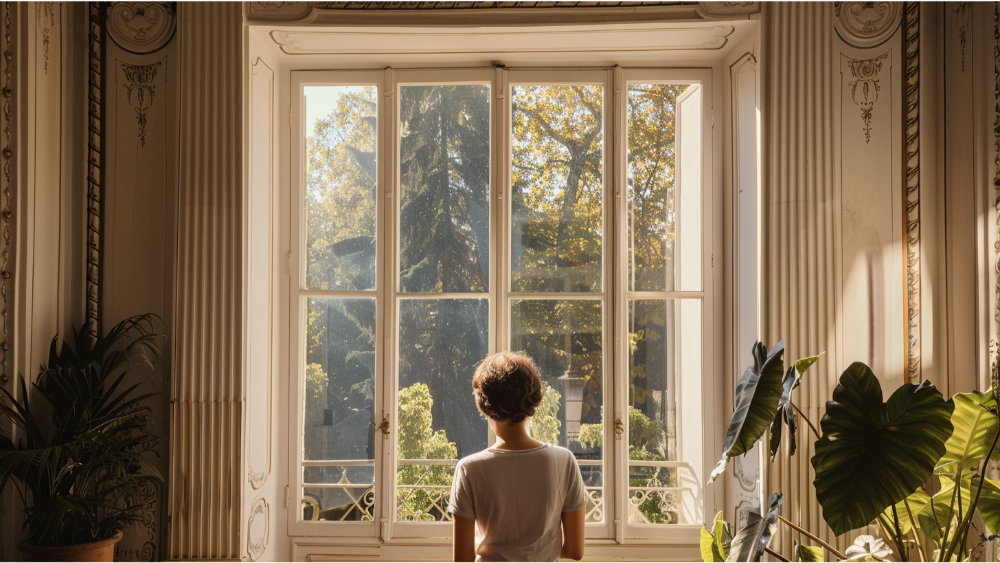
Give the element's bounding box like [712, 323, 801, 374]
[287, 67, 722, 545]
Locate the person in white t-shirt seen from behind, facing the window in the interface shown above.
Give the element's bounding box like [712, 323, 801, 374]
[448, 351, 586, 563]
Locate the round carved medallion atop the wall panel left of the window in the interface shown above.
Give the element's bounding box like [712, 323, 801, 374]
[107, 0, 177, 54]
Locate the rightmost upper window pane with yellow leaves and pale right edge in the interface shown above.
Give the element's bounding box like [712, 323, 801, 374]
[626, 84, 701, 291]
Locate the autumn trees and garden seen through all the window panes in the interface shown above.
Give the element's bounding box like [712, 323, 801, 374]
[303, 78, 687, 523]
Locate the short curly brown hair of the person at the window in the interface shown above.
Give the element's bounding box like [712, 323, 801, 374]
[472, 350, 542, 424]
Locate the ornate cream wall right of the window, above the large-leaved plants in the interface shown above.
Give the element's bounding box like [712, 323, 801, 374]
[761, 0, 1000, 553]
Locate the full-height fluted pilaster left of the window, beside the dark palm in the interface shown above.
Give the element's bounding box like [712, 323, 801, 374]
[169, 2, 244, 560]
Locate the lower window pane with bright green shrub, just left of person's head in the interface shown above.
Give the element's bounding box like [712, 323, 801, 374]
[396, 299, 490, 521]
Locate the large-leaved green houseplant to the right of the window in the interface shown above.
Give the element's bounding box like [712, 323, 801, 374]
[702, 343, 1000, 563]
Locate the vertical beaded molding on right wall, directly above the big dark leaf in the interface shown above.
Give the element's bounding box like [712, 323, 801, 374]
[903, 0, 922, 383]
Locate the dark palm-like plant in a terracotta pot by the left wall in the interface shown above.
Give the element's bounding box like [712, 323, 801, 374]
[0, 315, 162, 563]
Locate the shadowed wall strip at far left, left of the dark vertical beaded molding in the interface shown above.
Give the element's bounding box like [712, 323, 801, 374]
[0, 0, 87, 561]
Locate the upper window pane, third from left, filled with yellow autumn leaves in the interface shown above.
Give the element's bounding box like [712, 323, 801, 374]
[510, 85, 604, 292]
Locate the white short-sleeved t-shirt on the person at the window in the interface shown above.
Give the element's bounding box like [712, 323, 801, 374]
[448, 444, 586, 563]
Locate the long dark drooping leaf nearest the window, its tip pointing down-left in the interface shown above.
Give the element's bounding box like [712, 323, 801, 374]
[709, 341, 785, 483]
